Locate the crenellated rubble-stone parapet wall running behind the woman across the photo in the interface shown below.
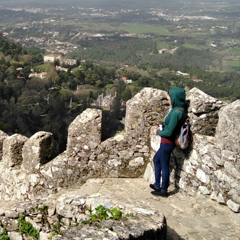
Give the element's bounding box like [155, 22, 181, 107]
[0, 88, 240, 212]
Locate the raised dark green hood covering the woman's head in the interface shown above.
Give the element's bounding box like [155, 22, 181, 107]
[169, 87, 186, 108]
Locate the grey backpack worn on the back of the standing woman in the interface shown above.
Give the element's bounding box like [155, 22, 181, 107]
[175, 118, 190, 149]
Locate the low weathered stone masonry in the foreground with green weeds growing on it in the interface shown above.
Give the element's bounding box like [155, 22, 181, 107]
[0, 187, 167, 240]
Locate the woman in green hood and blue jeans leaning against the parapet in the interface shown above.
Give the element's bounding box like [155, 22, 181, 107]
[150, 87, 187, 197]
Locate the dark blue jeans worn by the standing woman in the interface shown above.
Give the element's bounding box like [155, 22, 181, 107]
[153, 143, 175, 193]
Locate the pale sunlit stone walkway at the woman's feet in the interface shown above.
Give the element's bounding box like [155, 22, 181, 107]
[81, 178, 240, 240]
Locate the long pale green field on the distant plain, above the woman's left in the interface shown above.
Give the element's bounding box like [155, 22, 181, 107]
[120, 24, 169, 36]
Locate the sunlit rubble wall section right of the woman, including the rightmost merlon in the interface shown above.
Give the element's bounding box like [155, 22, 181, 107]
[174, 100, 240, 212]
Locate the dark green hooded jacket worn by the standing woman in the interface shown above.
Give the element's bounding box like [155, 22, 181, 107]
[157, 87, 187, 142]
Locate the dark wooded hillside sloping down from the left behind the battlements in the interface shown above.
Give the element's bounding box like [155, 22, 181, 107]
[0, 37, 135, 154]
